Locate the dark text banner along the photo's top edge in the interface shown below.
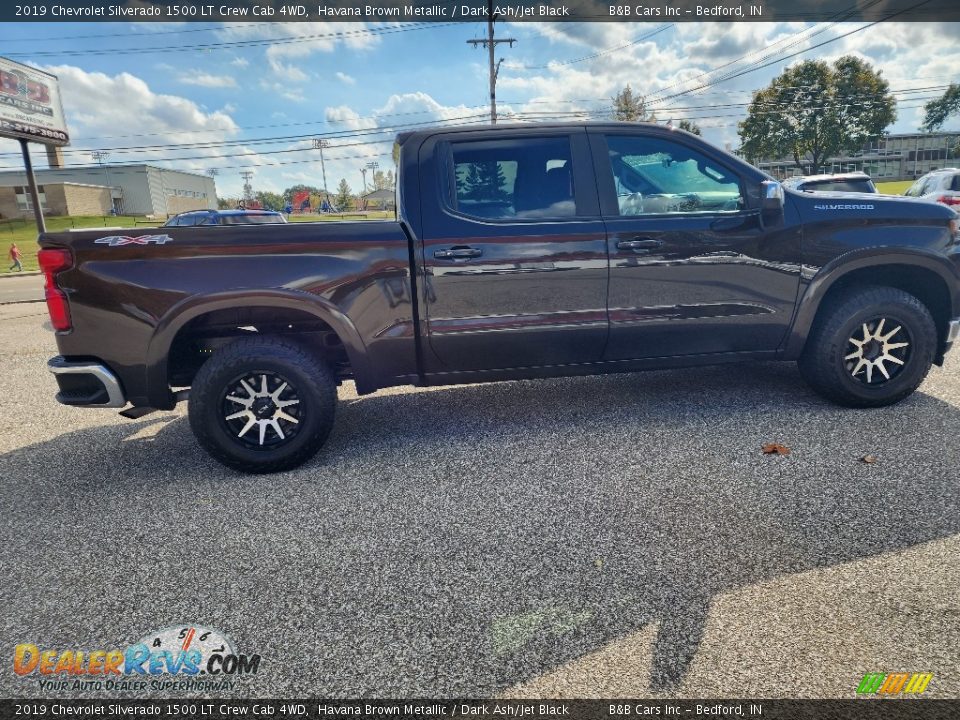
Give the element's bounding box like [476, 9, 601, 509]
[7, 0, 960, 23]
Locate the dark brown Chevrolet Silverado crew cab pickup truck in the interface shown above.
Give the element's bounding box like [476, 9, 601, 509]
[40, 123, 960, 472]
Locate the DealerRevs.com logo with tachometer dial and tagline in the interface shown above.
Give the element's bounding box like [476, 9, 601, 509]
[13, 624, 260, 691]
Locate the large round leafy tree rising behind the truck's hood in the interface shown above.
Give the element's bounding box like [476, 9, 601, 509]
[739, 55, 897, 173]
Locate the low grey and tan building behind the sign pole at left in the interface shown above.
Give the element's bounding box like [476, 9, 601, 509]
[0, 164, 217, 218]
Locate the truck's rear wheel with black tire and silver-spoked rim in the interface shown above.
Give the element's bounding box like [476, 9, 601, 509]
[189, 337, 337, 473]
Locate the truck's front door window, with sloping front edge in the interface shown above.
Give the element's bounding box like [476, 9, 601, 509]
[607, 135, 743, 216]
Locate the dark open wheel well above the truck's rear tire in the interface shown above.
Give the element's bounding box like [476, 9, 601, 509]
[167, 307, 353, 387]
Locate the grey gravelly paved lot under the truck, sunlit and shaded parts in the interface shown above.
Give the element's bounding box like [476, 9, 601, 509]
[0, 304, 960, 697]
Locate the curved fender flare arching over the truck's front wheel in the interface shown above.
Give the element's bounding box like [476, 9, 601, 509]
[782, 247, 960, 360]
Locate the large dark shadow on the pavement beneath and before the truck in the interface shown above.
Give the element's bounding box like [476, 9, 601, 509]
[0, 364, 960, 697]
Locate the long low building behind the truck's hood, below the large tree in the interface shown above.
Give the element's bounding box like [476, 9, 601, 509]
[754, 130, 960, 181]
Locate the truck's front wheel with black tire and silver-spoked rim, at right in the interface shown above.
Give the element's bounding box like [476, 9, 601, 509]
[799, 287, 937, 407]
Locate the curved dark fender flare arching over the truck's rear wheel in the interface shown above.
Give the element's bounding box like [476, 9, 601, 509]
[145, 289, 376, 410]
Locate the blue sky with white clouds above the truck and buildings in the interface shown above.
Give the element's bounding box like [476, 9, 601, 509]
[0, 22, 960, 197]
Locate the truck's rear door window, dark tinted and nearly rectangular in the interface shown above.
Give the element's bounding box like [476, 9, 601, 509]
[451, 136, 576, 220]
